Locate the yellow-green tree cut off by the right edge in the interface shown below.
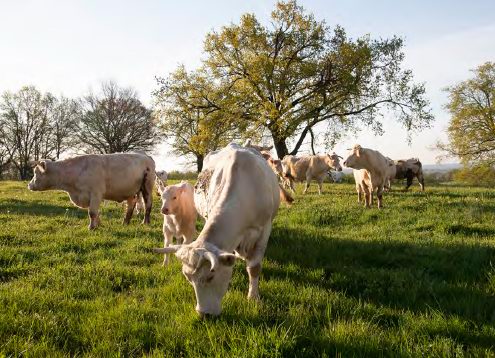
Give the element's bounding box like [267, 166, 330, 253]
[437, 62, 495, 165]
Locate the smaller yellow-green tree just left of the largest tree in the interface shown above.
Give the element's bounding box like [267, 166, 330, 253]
[154, 66, 237, 172]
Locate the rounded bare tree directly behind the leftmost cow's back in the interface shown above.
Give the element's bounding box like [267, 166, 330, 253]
[76, 82, 161, 154]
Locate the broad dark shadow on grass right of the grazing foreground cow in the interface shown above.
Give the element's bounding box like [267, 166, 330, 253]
[263, 227, 495, 347]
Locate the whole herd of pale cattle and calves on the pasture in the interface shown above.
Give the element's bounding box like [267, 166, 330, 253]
[28, 141, 424, 316]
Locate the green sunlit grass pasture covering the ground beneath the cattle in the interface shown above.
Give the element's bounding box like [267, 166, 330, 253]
[0, 182, 495, 357]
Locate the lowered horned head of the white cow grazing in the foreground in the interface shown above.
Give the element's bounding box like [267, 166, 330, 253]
[154, 242, 235, 317]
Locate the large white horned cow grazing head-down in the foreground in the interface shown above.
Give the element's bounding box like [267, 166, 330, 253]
[155, 144, 281, 316]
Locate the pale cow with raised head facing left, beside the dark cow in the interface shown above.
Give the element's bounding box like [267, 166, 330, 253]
[344, 144, 391, 208]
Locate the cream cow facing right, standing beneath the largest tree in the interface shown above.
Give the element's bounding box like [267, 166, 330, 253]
[282, 153, 342, 194]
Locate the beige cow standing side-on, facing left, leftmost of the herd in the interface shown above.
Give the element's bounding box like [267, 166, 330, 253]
[28, 153, 155, 229]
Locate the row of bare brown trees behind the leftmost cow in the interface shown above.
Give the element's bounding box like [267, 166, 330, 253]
[0, 82, 162, 180]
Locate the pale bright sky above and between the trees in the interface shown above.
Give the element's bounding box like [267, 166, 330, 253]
[0, 0, 495, 170]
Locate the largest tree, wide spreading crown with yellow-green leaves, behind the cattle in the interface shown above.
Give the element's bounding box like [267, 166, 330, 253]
[197, 1, 433, 157]
